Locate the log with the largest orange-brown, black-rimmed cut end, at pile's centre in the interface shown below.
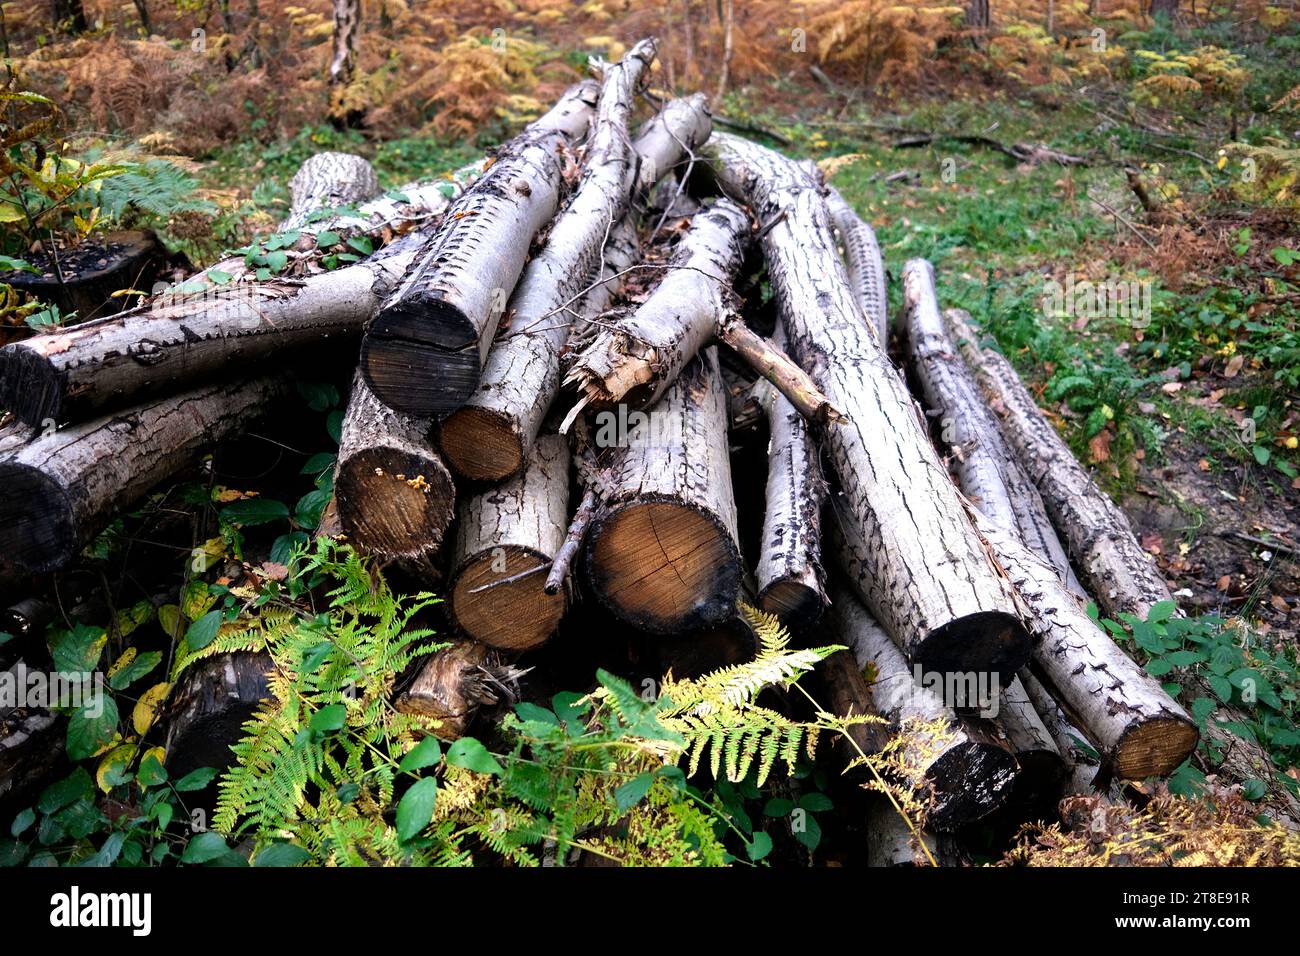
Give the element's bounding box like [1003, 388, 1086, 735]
[586, 347, 741, 633]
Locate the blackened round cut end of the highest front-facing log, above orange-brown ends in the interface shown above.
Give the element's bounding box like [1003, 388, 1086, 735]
[361, 299, 482, 419]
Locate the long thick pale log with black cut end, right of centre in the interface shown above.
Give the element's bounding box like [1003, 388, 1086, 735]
[711, 137, 1028, 676]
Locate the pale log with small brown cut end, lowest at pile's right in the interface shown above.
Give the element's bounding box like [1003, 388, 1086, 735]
[976, 516, 1199, 780]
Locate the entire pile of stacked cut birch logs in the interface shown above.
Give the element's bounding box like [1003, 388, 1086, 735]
[0, 40, 1227, 864]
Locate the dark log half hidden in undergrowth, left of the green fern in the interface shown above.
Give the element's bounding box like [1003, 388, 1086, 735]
[165, 652, 273, 778]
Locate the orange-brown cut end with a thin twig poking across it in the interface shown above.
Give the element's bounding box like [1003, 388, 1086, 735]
[451, 545, 567, 650]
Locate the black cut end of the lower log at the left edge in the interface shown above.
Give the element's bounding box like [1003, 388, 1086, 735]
[0, 462, 78, 574]
